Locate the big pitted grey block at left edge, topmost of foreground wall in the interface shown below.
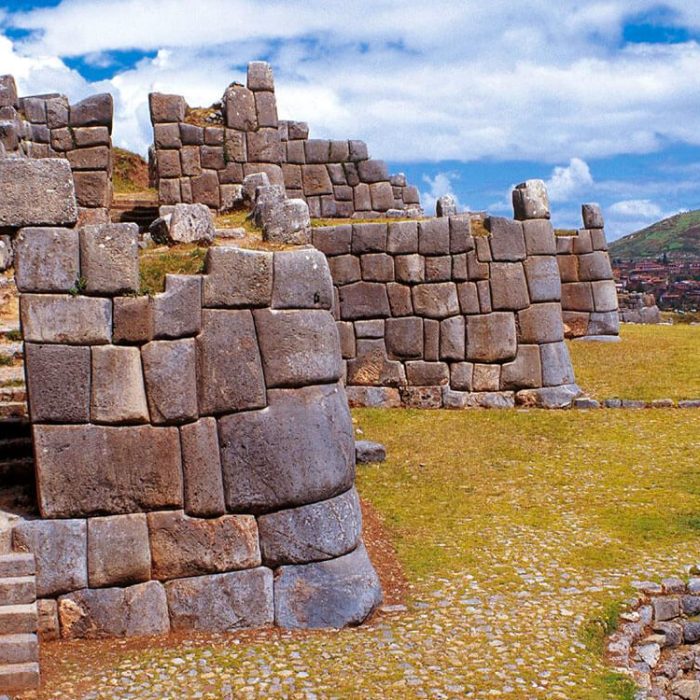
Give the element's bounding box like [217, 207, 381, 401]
[0, 158, 78, 228]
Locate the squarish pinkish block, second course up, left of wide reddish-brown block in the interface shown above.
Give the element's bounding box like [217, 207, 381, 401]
[87, 513, 151, 588]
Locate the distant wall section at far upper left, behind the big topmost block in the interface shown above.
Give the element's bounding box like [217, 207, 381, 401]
[0, 75, 113, 223]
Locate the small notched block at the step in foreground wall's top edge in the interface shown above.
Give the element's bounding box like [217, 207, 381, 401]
[151, 275, 202, 338]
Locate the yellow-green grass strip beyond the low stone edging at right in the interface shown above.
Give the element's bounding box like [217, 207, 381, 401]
[569, 325, 700, 401]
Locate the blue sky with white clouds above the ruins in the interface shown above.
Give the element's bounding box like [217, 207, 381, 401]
[0, 0, 700, 238]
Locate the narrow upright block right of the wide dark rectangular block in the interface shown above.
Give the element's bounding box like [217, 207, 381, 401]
[180, 418, 226, 518]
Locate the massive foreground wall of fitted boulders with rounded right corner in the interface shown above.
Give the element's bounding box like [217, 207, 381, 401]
[6, 160, 381, 638]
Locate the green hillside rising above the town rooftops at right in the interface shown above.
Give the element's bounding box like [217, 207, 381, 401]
[610, 209, 700, 260]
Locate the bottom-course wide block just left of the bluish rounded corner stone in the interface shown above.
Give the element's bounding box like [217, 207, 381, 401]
[165, 567, 274, 632]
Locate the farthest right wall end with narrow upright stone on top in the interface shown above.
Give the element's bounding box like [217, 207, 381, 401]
[557, 204, 620, 338]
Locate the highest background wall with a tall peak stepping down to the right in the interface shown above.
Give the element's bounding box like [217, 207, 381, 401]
[149, 62, 420, 217]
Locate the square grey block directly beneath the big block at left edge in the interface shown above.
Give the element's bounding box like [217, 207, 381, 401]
[15, 228, 80, 292]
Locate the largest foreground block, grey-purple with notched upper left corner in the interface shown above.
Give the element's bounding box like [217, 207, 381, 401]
[219, 384, 355, 513]
